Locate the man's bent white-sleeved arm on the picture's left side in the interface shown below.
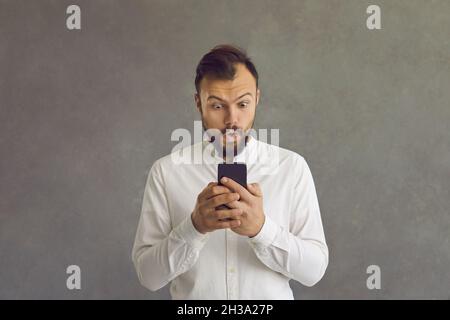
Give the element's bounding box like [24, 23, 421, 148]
[132, 163, 208, 291]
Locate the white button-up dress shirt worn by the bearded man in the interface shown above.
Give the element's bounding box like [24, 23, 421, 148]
[132, 138, 328, 300]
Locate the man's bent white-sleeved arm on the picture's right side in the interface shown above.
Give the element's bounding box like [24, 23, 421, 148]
[249, 158, 328, 286]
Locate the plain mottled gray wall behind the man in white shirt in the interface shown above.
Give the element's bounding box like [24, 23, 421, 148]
[0, 0, 450, 299]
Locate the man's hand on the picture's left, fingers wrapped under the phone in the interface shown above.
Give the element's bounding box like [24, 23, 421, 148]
[191, 182, 242, 234]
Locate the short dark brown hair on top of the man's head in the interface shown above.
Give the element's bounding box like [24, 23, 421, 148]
[195, 44, 258, 93]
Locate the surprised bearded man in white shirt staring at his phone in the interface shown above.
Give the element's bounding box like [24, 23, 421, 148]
[132, 45, 328, 299]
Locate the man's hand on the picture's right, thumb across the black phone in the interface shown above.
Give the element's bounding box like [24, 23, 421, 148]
[220, 177, 266, 238]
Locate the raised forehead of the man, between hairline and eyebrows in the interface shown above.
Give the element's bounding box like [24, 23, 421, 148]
[200, 64, 256, 99]
